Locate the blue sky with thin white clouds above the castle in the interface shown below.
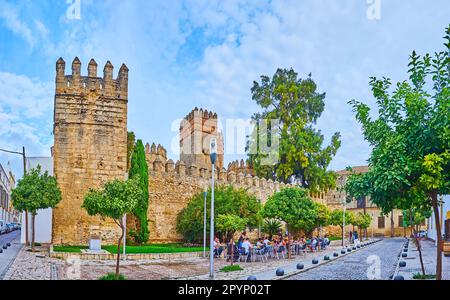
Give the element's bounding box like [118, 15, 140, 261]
[0, 0, 450, 178]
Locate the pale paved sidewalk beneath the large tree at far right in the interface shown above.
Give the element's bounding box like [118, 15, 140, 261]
[396, 239, 450, 280]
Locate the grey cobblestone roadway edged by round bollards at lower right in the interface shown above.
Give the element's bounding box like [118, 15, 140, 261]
[288, 238, 405, 280]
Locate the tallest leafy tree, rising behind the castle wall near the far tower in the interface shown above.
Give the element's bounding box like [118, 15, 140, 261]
[247, 69, 341, 192]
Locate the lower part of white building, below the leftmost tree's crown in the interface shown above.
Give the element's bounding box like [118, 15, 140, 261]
[20, 208, 53, 244]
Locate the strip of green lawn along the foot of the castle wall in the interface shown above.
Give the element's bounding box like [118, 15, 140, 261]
[53, 244, 208, 254]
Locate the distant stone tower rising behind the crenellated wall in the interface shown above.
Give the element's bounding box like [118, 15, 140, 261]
[180, 107, 224, 170]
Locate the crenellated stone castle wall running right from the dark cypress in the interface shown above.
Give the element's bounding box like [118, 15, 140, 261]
[145, 139, 288, 242]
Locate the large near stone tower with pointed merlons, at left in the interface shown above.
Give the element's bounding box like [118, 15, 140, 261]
[52, 58, 128, 245]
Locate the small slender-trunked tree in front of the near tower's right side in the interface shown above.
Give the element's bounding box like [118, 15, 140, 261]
[82, 177, 143, 278]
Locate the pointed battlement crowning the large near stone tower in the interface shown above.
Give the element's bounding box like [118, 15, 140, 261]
[55, 57, 129, 101]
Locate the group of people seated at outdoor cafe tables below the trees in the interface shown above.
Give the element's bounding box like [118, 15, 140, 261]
[214, 231, 330, 260]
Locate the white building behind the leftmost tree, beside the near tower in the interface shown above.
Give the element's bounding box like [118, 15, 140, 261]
[20, 157, 53, 244]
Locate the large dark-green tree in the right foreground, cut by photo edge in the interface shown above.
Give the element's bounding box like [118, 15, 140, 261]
[349, 26, 450, 280]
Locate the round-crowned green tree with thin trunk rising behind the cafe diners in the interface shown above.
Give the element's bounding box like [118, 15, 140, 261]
[261, 188, 318, 257]
